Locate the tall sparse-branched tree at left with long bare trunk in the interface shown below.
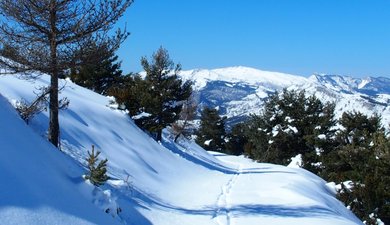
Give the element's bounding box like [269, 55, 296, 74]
[0, 0, 133, 147]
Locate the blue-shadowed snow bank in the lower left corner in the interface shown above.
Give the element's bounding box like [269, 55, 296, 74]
[0, 95, 119, 225]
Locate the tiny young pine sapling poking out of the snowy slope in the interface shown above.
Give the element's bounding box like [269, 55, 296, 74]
[85, 145, 108, 186]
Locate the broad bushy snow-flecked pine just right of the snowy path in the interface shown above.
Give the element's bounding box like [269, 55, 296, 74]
[245, 89, 336, 171]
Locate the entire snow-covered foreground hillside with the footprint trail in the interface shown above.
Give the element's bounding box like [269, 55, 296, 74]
[0, 76, 362, 225]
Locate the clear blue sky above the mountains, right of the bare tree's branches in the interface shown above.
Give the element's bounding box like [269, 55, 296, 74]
[118, 0, 390, 77]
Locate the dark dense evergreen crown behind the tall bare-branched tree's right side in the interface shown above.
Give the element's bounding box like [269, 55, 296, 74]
[70, 43, 122, 95]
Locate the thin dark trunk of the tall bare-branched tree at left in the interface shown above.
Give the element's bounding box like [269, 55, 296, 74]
[48, 1, 60, 147]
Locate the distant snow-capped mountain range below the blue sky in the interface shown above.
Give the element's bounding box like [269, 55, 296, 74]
[181, 66, 390, 125]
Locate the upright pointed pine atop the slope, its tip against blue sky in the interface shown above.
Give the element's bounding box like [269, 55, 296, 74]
[136, 47, 192, 141]
